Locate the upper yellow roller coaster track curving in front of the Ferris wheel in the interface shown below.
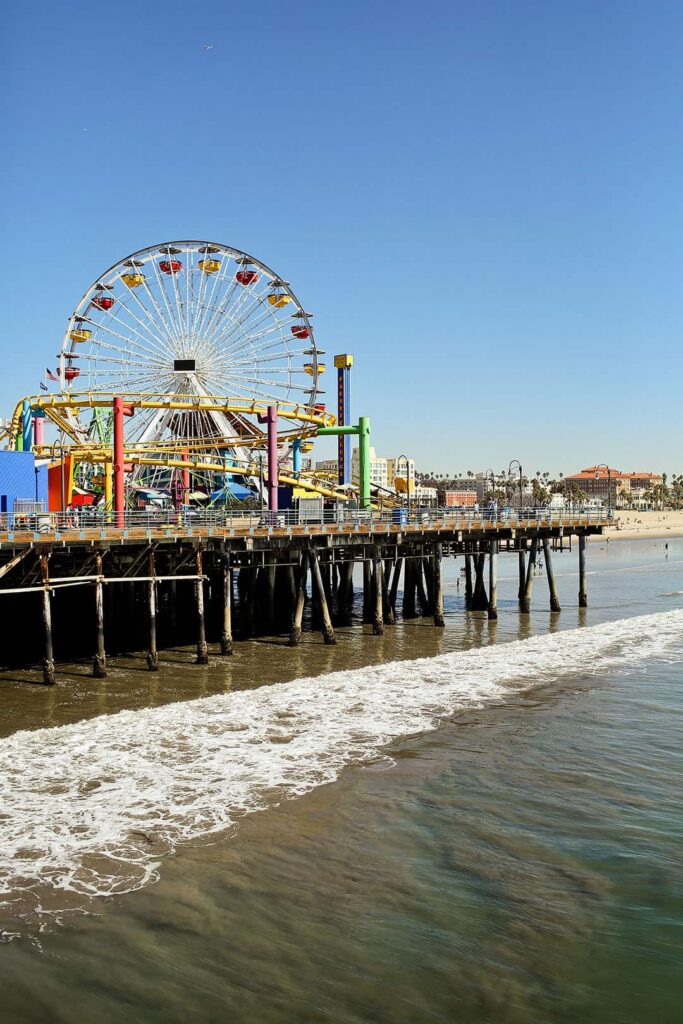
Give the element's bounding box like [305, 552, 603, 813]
[7, 391, 337, 446]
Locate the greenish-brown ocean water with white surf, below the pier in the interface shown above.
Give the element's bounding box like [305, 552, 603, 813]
[0, 541, 683, 1024]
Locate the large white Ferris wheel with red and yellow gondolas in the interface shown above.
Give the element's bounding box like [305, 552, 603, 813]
[58, 241, 325, 460]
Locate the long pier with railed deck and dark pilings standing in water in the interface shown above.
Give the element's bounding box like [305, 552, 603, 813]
[0, 509, 610, 685]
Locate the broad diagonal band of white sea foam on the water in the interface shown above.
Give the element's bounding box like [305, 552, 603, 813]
[0, 610, 683, 931]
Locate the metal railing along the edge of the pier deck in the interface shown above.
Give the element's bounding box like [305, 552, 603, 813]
[0, 506, 613, 543]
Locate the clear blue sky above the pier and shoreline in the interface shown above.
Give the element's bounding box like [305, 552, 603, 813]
[0, 0, 683, 474]
